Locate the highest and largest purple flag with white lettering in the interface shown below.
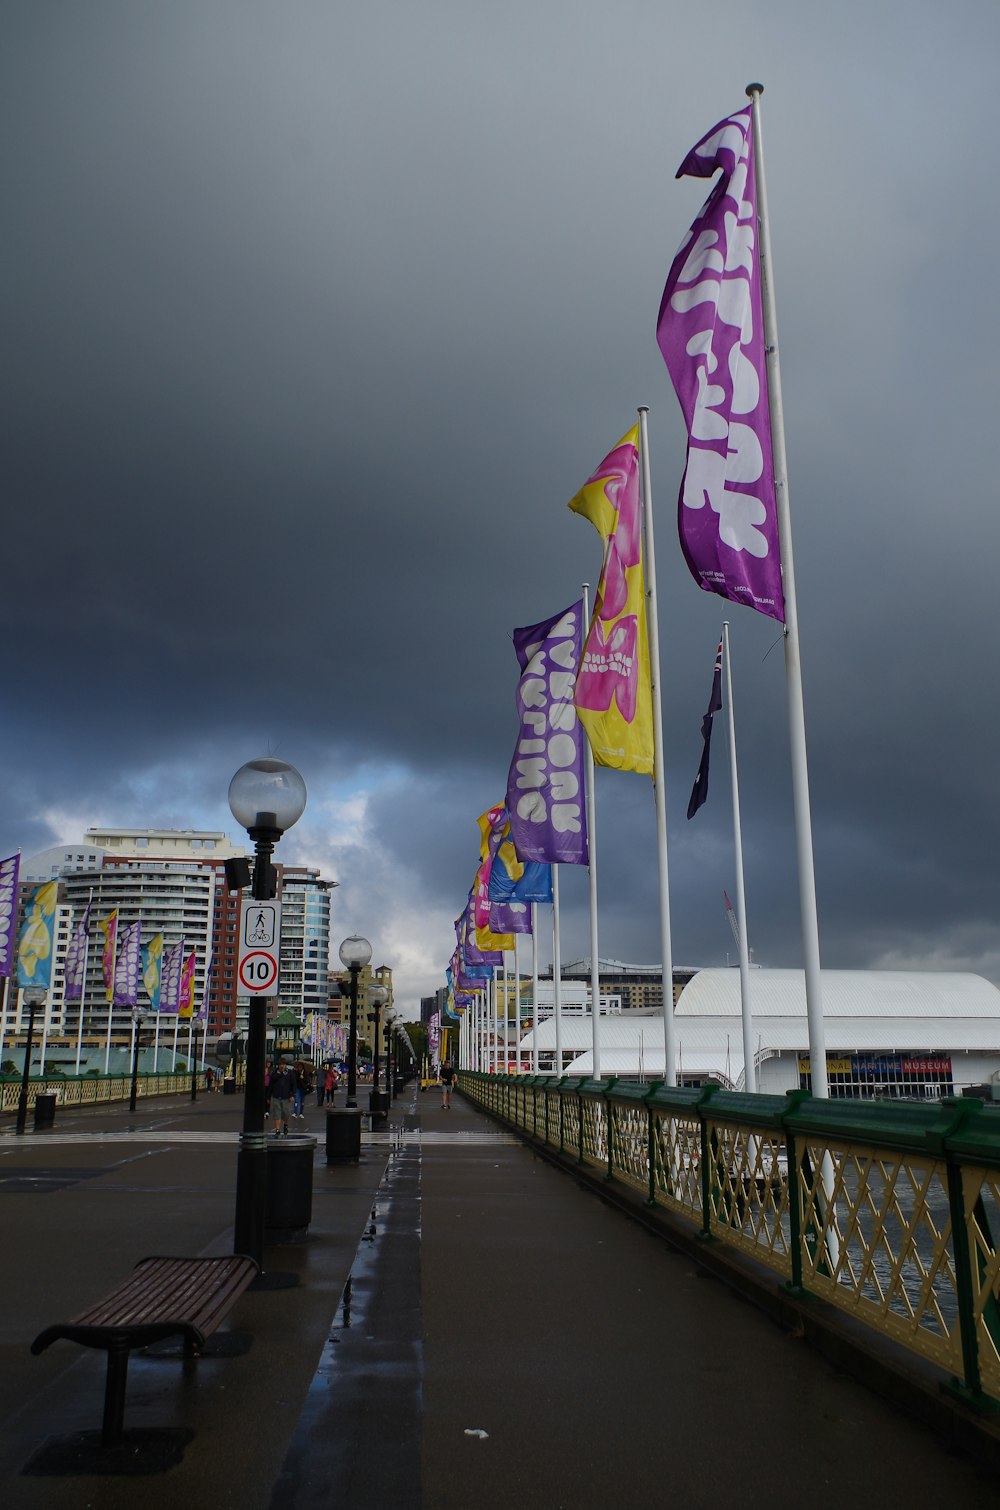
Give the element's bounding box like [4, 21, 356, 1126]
[656, 106, 784, 622]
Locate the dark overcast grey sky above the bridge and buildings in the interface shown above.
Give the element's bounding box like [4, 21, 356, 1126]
[0, 0, 1000, 1009]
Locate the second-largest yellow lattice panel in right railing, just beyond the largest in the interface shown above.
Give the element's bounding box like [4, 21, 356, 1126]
[708, 1122, 792, 1276]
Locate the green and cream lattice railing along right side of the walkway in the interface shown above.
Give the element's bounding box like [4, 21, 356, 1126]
[459, 1071, 1000, 1412]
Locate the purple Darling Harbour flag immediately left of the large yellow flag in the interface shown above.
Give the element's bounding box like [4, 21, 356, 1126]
[508, 602, 589, 865]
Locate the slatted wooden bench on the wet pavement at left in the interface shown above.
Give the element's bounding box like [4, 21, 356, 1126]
[32, 1255, 258, 1447]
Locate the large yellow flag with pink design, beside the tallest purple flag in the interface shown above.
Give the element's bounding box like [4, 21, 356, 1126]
[568, 424, 653, 776]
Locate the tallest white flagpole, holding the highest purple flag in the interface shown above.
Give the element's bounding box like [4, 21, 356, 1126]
[746, 85, 829, 1096]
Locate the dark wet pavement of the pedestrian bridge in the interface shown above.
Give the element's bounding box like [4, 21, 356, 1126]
[0, 1086, 995, 1510]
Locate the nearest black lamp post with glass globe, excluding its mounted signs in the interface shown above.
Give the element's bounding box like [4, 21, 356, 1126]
[230, 757, 305, 1264]
